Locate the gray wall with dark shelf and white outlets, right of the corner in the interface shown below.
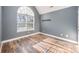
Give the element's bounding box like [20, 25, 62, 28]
[41, 6, 78, 41]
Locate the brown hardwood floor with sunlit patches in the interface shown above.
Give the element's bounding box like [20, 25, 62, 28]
[1, 34, 79, 53]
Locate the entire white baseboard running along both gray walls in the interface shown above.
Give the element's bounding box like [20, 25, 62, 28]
[1, 32, 78, 44]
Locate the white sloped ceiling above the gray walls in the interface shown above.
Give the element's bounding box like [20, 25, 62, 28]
[36, 6, 70, 14]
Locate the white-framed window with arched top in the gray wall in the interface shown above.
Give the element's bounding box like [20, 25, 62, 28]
[17, 7, 35, 32]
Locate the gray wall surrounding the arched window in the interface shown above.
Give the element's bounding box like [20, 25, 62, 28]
[2, 6, 39, 41]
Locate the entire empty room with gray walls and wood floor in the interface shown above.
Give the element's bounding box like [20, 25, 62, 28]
[0, 6, 79, 53]
